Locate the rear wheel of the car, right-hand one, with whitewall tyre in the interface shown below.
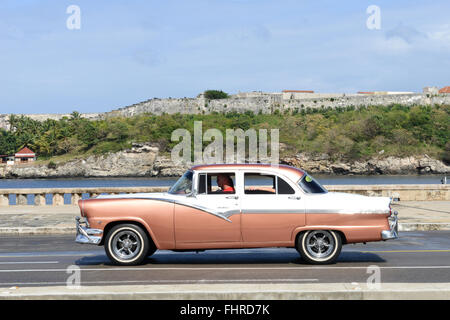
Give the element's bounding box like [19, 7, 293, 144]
[297, 230, 342, 264]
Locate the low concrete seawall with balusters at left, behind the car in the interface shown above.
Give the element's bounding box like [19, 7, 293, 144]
[0, 184, 450, 206]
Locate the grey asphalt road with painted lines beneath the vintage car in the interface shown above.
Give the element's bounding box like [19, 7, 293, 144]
[0, 231, 450, 288]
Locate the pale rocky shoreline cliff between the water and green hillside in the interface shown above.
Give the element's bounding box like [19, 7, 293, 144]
[0, 144, 450, 178]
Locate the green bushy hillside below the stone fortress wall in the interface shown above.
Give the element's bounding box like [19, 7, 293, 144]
[0, 105, 450, 163]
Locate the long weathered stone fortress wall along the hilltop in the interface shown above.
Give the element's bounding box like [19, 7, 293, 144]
[0, 87, 450, 129]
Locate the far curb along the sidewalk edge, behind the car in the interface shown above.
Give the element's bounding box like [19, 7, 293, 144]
[0, 222, 450, 236]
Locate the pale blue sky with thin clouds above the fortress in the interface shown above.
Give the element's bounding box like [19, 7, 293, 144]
[0, 0, 450, 114]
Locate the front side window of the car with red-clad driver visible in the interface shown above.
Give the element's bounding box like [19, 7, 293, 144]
[197, 172, 236, 195]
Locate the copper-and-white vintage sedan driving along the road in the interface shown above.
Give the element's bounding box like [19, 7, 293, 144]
[76, 164, 397, 265]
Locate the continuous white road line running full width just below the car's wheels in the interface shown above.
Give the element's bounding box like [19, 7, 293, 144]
[0, 266, 450, 273]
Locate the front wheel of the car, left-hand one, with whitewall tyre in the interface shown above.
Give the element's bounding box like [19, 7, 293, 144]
[105, 224, 149, 266]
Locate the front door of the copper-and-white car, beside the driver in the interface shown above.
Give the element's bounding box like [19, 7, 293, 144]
[175, 172, 241, 249]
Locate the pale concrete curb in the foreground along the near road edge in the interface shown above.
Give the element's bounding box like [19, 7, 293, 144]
[0, 283, 450, 300]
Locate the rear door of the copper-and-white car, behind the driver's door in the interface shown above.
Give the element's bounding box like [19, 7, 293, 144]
[241, 172, 305, 247]
